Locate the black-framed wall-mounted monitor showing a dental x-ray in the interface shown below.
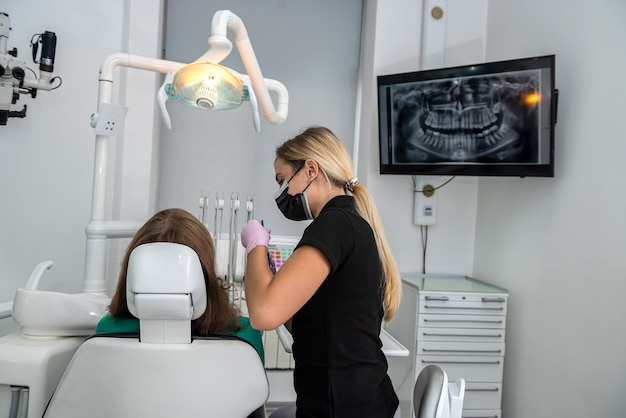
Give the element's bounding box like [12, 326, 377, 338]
[377, 55, 558, 177]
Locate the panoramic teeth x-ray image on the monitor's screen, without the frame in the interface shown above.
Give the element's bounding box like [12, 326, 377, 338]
[391, 70, 541, 164]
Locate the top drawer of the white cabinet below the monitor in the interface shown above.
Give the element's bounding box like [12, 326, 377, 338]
[419, 294, 507, 315]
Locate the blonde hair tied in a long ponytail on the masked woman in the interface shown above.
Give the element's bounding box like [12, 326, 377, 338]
[276, 126, 402, 321]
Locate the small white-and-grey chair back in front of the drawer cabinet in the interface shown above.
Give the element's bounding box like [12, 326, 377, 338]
[413, 364, 465, 418]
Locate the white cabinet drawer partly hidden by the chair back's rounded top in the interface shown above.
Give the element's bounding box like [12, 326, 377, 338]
[415, 355, 504, 382]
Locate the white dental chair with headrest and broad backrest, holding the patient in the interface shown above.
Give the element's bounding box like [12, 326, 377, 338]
[44, 243, 269, 418]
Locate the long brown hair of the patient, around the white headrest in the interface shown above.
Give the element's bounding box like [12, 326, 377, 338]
[109, 209, 239, 335]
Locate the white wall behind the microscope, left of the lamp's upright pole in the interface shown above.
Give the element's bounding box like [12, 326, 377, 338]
[0, 0, 124, 294]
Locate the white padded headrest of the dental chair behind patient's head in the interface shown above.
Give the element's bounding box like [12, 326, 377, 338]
[126, 242, 207, 320]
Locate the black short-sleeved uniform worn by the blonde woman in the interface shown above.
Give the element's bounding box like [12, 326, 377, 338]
[292, 196, 398, 418]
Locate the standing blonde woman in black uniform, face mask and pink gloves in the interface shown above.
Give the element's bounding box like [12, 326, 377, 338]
[241, 127, 401, 418]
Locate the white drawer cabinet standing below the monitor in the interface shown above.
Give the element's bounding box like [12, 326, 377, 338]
[386, 274, 508, 418]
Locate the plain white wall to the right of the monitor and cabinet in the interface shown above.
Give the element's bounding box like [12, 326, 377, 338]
[474, 0, 626, 418]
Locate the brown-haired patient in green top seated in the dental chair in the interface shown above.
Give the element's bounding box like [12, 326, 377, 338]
[96, 208, 265, 361]
